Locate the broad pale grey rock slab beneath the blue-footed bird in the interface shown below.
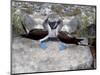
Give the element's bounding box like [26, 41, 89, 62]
[12, 37, 93, 73]
